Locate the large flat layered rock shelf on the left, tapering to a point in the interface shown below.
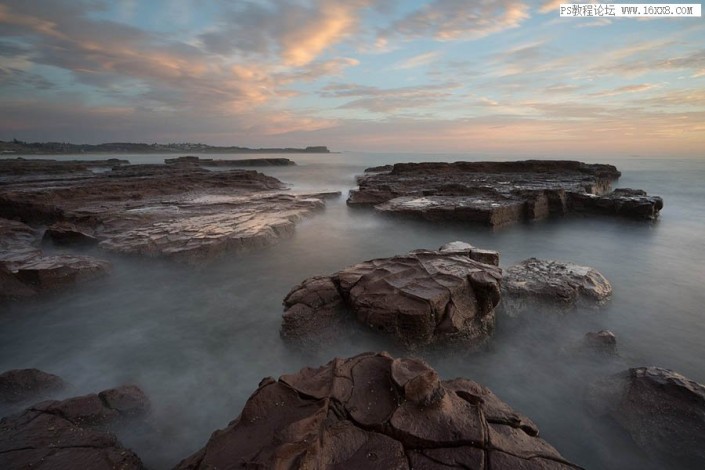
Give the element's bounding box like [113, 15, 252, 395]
[0, 160, 338, 262]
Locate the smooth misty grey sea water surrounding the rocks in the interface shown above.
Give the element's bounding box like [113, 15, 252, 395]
[0, 153, 705, 469]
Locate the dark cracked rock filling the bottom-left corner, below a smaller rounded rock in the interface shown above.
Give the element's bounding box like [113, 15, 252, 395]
[0, 384, 143, 470]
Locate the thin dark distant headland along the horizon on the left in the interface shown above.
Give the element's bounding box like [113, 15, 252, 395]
[0, 139, 331, 155]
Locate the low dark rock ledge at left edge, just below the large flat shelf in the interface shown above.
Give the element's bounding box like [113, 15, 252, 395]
[0, 218, 110, 300]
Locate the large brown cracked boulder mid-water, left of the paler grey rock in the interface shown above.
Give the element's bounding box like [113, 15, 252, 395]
[282, 247, 501, 347]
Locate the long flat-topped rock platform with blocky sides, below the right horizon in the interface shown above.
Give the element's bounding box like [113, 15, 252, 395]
[348, 160, 663, 227]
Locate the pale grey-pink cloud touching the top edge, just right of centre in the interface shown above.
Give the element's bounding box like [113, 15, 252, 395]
[381, 0, 529, 41]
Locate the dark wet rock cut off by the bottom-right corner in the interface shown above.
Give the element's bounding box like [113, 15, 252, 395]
[588, 367, 705, 468]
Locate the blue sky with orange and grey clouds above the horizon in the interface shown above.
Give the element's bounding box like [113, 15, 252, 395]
[0, 0, 705, 158]
